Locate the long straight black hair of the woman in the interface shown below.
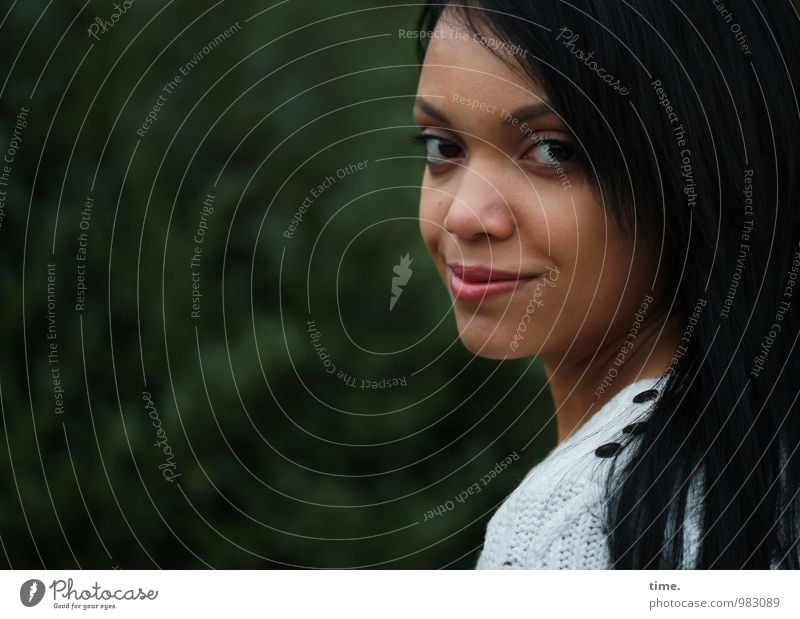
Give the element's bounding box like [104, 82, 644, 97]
[419, 0, 800, 569]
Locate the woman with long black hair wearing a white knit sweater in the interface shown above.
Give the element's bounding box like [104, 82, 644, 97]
[414, 0, 800, 569]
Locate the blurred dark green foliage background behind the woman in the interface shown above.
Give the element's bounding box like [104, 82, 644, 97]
[0, 0, 555, 569]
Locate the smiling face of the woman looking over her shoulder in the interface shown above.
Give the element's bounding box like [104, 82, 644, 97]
[414, 12, 657, 361]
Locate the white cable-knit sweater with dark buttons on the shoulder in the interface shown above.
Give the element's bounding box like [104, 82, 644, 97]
[476, 378, 696, 569]
